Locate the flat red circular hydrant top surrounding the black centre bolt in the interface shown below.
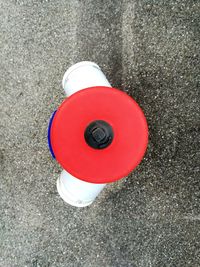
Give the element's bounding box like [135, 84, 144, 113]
[50, 86, 148, 183]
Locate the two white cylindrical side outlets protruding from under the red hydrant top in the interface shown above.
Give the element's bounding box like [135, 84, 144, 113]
[57, 61, 111, 207]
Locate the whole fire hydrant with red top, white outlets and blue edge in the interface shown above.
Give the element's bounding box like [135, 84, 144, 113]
[48, 61, 148, 207]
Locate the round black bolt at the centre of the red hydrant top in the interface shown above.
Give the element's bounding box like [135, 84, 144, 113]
[84, 120, 114, 149]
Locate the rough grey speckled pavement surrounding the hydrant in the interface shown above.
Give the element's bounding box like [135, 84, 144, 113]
[0, 0, 200, 267]
